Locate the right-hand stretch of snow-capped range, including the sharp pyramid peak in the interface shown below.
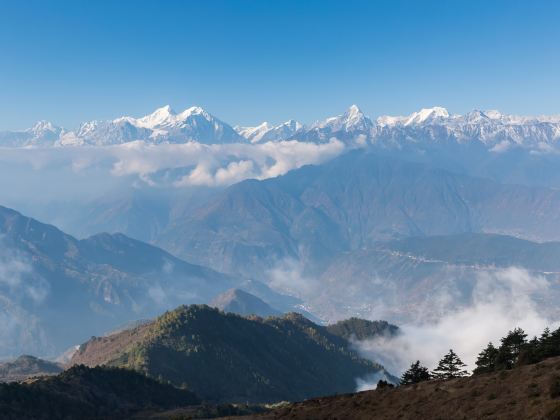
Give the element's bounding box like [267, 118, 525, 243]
[293, 105, 560, 152]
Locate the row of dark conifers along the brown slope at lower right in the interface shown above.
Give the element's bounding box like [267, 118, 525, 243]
[400, 328, 560, 385]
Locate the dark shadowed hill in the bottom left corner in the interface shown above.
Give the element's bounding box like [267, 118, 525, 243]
[0, 366, 200, 420]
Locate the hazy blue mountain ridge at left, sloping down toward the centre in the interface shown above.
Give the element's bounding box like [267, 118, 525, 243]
[0, 203, 310, 359]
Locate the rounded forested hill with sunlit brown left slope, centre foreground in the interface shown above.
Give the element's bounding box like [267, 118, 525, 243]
[71, 305, 394, 402]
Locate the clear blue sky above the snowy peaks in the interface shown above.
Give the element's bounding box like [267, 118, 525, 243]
[0, 0, 560, 129]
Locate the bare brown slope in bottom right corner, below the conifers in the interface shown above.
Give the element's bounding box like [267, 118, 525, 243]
[236, 358, 560, 420]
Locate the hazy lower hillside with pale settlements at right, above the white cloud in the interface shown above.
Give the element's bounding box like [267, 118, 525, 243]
[306, 233, 560, 324]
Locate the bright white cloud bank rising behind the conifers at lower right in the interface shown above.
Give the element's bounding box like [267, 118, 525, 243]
[355, 267, 558, 375]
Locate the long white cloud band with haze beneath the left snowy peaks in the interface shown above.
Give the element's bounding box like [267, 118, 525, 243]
[0, 139, 345, 203]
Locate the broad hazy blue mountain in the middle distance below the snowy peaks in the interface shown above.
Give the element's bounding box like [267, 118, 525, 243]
[155, 152, 560, 276]
